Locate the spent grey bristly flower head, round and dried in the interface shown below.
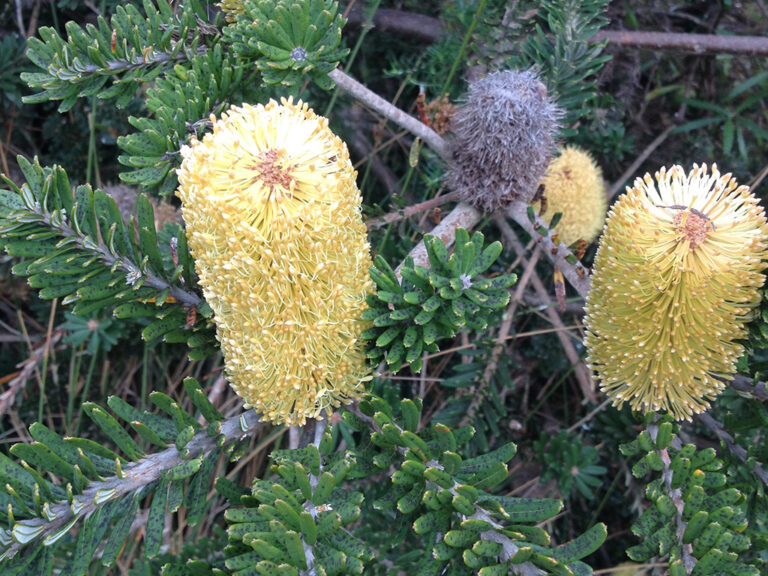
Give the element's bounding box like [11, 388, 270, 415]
[446, 70, 561, 212]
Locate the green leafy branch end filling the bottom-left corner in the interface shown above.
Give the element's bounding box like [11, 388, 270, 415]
[0, 378, 226, 576]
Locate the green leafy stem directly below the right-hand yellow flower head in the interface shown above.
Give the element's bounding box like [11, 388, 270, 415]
[621, 421, 761, 576]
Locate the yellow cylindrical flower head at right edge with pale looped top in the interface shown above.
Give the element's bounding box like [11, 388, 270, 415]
[585, 165, 768, 420]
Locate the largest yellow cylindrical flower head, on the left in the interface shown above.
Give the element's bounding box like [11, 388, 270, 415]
[177, 100, 372, 424]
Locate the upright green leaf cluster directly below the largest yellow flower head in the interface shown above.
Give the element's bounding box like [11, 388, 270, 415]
[225, 433, 374, 576]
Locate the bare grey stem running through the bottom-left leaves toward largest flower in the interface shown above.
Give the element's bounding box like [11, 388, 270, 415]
[9, 410, 261, 555]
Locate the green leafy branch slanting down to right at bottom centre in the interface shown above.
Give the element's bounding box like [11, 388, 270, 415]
[344, 395, 606, 576]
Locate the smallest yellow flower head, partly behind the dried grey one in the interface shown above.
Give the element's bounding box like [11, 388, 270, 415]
[541, 146, 608, 245]
